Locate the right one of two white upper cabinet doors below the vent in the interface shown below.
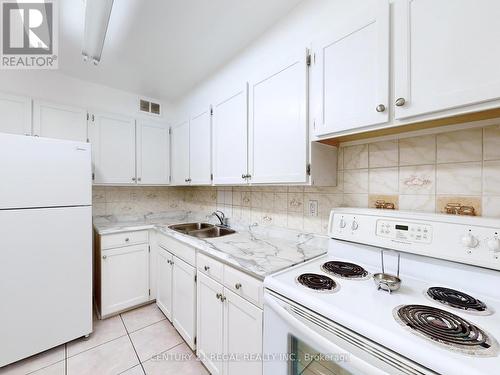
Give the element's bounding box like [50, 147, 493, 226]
[137, 121, 170, 185]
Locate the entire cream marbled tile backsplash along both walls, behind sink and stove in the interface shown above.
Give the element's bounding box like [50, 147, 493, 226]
[93, 122, 500, 233]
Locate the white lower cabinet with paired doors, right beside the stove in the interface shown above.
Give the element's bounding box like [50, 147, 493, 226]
[197, 255, 263, 375]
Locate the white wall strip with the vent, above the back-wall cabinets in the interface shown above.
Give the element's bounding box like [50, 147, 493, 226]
[0, 70, 173, 122]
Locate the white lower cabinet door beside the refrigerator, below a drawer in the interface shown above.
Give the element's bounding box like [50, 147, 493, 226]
[101, 244, 149, 316]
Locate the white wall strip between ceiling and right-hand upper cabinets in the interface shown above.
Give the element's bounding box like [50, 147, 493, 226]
[177, 0, 376, 122]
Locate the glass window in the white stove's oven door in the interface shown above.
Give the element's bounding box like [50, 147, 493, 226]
[289, 335, 353, 375]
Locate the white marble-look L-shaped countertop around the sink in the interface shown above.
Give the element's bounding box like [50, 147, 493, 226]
[94, 212, 329, 279]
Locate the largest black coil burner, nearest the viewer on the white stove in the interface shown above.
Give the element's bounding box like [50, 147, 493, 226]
[394, 305, 498, 356]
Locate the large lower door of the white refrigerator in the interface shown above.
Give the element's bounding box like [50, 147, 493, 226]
[0, 207, 92, 367]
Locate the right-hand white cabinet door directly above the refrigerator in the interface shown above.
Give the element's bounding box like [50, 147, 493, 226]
[33, 100, 87, 142]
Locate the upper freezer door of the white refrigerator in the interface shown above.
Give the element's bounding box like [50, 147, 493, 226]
[0, 134, 92, 210]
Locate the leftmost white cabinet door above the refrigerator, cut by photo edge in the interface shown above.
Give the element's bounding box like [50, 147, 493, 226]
[0, 93, 31, 135]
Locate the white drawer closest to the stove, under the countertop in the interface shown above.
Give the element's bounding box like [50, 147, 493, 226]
[224, 266, 264, 308]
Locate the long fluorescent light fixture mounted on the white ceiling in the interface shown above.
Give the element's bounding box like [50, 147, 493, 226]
[82, 0, 113, 65]
